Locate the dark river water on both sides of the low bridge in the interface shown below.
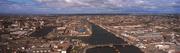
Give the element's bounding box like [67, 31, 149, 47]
[86, 24, 143, 53]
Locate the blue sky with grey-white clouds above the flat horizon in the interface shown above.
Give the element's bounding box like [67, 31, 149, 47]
[0, 0, 180, 14]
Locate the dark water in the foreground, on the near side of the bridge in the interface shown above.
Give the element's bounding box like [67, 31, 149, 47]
[86, 45, 143, 53]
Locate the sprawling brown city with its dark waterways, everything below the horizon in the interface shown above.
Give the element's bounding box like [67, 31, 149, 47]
[0, 15, 180, 53]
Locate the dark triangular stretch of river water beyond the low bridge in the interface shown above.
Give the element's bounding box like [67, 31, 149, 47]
[87, 24, 127, 45]
